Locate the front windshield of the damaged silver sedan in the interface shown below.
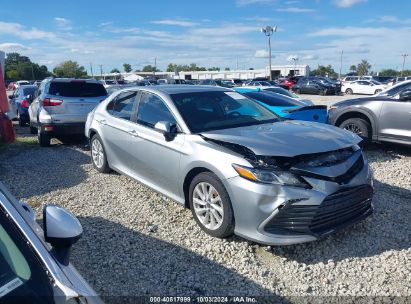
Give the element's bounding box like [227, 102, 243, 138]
[170, 91, 279, 133]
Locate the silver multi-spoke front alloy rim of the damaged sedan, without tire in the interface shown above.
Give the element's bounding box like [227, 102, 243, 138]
[193, 182, 224, 230]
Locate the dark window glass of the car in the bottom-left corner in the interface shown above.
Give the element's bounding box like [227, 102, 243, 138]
[0, 209, 54, 303]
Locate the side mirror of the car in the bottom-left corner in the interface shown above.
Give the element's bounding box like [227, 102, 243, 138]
[43, 205, 83, 266]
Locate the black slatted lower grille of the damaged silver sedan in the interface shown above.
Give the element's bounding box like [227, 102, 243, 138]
[264, 185, 373, 236]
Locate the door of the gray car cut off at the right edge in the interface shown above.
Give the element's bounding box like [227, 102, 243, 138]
[378, 94, 411, 141]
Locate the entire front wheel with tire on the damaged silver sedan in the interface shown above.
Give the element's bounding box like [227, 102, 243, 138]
[189, 172, 235, 238]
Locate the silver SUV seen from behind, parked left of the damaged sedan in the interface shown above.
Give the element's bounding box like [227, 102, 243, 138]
[29, 78, 107, 147]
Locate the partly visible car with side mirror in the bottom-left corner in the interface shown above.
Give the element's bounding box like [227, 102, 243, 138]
[0, 183, 102, 304]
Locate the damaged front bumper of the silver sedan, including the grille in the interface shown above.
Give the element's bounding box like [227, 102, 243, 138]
[225, 150, 372, 245]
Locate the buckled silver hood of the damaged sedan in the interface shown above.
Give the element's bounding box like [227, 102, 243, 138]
[201, 121, 361, 157]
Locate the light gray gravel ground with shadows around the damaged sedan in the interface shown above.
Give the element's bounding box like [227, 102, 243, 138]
[0, 121, 411, 303]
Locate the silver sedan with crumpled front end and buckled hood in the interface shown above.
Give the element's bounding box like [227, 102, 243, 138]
[85, 85, 373, 244]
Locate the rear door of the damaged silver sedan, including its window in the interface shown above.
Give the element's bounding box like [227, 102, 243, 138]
[99, 90, 138, 175]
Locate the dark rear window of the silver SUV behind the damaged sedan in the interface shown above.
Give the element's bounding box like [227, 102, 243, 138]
[49, 81, 107, 97]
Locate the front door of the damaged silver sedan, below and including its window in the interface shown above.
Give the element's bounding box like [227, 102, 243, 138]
[130, 92, 184, 197]
